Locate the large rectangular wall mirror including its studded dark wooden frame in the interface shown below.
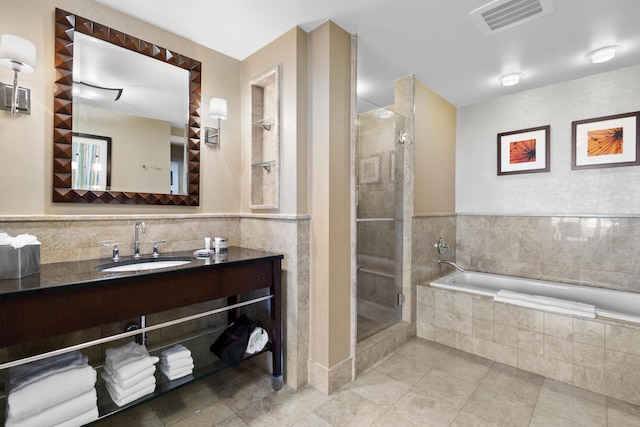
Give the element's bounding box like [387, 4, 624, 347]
[53, 9, 201, 206]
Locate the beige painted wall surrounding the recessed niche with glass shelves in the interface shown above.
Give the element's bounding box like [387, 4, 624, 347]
[241, 27, 309, 214]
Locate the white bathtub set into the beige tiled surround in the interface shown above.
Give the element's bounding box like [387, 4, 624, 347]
[429, 271, 640, 324]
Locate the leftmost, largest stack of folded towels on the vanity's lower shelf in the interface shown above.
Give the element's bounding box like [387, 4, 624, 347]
[5, 351, 98, 427]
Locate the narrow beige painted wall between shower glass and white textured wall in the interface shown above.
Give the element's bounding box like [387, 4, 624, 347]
[414, 80, 456, 214]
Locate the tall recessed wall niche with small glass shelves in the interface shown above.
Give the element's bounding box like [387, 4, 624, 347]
[249, 67, 280, 209]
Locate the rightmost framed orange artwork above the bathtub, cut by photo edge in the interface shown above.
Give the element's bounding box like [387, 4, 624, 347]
[571, 111, 640, 170]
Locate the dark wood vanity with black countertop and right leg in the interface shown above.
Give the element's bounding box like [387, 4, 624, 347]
[0, 247, 283, 384]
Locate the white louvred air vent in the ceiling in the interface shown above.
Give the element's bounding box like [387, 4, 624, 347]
[469, 0, 555, 36]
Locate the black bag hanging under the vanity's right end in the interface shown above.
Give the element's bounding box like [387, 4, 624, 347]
[209, 314, 260, 369]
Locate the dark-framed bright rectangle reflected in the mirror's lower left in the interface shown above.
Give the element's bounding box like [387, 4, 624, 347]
[71, 132, 111, 191]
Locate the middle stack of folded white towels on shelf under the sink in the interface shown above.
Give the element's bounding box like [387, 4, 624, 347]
[100, 341, 160, 406]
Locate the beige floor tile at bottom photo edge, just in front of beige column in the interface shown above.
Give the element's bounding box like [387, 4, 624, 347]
[314, 389, 385, 427]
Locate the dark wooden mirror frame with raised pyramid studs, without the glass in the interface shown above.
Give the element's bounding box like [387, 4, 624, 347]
[53, 8, 202, 206]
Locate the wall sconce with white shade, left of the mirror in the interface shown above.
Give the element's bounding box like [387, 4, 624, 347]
[0, 34, 36, 115]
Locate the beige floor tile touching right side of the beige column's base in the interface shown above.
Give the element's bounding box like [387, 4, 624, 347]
[345, 371, 411, 408]
